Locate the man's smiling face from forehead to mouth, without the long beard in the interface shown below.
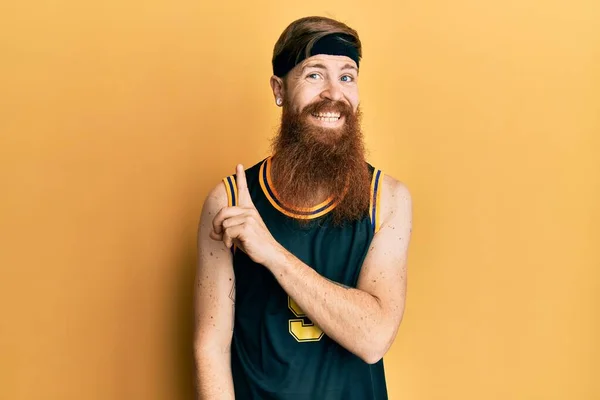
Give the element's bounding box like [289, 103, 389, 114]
[284, 54, 359, 130]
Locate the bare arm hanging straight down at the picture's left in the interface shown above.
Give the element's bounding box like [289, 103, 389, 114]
[194, 183, 235, 400]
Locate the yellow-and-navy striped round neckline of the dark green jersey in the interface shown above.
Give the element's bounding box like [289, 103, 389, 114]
[258, 156, 338, 219]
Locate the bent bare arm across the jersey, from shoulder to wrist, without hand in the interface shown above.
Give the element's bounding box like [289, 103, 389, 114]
[266, 177, 412, 363]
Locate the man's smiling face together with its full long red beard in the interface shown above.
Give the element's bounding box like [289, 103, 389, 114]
[271, 55, 371, 225]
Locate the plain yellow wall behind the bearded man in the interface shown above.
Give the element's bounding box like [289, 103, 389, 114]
[0, 0, 600, 400]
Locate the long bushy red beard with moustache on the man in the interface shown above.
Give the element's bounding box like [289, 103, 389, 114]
[272, 100, 371, 225]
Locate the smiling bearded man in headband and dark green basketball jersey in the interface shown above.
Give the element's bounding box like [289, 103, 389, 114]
[195, 17, 411, 400]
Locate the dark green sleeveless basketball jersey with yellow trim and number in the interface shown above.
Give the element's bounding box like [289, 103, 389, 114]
[223, 157, 387, 400]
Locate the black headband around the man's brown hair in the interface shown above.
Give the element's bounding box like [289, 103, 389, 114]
[273, 33, 360, 78]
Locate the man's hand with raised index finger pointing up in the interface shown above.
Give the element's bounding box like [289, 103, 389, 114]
[210, 164, 281, 265]
